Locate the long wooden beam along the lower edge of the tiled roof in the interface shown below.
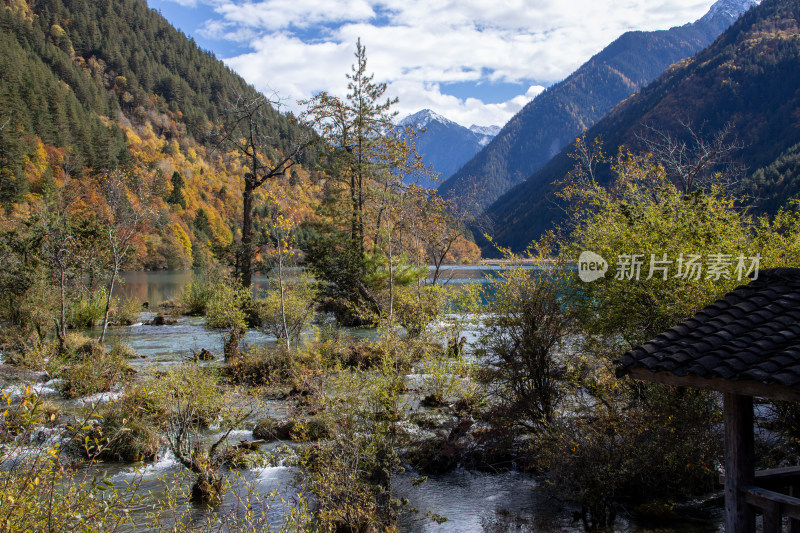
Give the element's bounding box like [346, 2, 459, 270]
[630, 368, 800, 402]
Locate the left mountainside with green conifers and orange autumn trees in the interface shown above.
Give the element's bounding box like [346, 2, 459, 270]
[0, 0, 317, 268]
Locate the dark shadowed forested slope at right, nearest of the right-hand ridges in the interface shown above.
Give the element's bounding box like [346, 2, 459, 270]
[487, 0, 800, 254]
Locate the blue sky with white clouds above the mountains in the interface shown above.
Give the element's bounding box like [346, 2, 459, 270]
[148, 0, 714, 126]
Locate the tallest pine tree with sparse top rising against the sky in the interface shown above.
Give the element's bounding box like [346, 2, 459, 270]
[306, 39, 416, 320]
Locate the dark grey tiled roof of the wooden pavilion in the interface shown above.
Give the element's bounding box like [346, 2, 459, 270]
[617, 268, 800, 390]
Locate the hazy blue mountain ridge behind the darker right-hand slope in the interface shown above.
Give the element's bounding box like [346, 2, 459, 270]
[439, 0, 756, 213]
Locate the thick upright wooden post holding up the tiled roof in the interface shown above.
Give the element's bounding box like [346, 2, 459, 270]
[722, 392, 756, 533]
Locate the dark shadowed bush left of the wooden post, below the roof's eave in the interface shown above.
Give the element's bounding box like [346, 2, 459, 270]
[531, 385, 722, 527]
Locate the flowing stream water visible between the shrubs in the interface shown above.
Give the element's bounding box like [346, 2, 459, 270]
[0, 267, 723, 533]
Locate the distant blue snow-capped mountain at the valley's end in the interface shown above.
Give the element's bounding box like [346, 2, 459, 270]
[399, 109, 500, 189]
